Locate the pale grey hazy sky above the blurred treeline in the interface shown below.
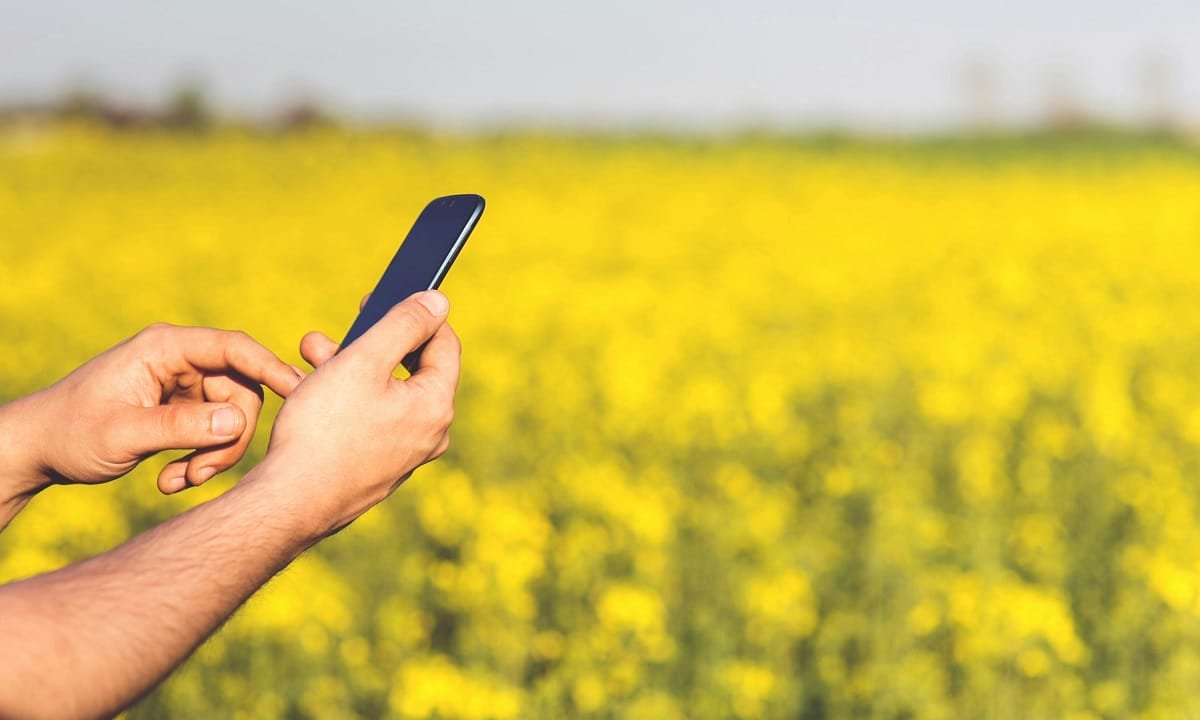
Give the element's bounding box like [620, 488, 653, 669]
[0, 0, 1200, 128]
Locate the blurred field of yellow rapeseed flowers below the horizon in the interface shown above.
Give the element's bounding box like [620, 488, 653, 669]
[0, 127, 1200, 720]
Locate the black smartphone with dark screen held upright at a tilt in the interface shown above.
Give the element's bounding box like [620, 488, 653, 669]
[337, 194, 484, 360]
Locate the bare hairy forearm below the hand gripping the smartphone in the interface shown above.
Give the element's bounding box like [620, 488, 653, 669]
[0, 463, 316, 718]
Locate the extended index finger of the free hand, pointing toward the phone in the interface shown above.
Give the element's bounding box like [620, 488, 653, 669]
[156, 328, 300, 397]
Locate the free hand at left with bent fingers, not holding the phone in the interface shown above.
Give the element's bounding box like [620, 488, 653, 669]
[2, 324, 300, 494]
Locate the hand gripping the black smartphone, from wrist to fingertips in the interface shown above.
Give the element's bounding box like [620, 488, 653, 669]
[253, 290, 462, 539]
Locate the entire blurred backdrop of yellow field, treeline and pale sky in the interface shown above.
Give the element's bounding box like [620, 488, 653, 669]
[0, 0, 1200, 720]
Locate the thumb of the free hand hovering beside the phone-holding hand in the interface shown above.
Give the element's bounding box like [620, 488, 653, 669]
[121, 402, 246, 456]
